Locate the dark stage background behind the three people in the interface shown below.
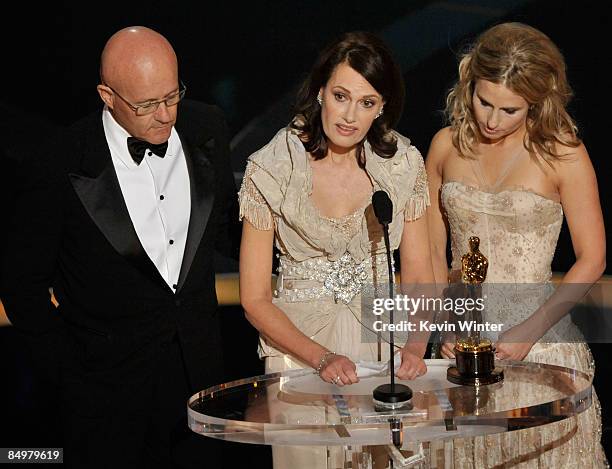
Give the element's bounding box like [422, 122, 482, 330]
[0, 0, 612, 460]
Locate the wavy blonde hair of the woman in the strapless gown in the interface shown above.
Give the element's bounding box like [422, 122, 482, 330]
[445, 23, 580, 159]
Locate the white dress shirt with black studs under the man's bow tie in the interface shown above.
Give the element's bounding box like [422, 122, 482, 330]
[102, 107, 191, 292]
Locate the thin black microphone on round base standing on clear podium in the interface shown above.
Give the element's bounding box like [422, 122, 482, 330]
[372, 190, 412, 420]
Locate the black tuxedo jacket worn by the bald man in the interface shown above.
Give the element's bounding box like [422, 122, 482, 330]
[2, 100, 239, 412]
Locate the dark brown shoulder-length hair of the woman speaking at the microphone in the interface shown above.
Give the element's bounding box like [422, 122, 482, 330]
[290, 31, 404, 167]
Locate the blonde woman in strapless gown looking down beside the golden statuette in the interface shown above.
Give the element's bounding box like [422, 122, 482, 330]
[426, 23, 606, 468]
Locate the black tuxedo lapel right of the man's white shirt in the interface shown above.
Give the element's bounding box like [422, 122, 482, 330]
[177, 133, 215, 293]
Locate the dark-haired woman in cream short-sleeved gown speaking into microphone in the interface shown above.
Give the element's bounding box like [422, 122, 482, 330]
[239, 33, 433, 467]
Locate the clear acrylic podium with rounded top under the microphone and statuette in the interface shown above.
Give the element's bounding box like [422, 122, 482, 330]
[188, 359, 592, 468]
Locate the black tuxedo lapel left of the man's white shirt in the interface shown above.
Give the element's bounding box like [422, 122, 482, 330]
[69, 120, 172, 292]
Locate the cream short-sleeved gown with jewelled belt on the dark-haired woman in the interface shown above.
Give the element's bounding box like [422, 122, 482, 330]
[239, 128, 429, 469]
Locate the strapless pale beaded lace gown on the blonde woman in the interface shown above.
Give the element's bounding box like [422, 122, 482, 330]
[441, 181, 607, 468]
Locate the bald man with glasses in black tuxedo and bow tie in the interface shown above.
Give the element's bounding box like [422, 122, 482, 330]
[2, 27, 239, 468]
